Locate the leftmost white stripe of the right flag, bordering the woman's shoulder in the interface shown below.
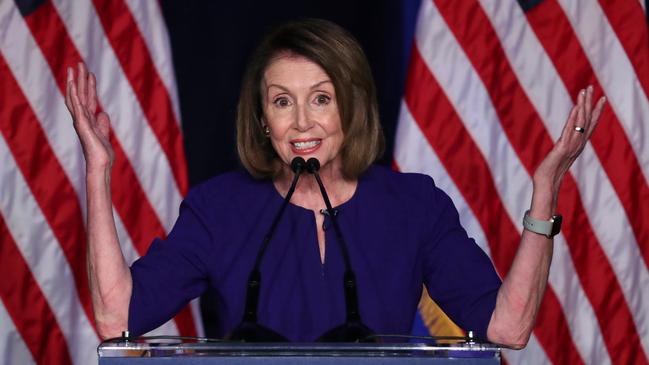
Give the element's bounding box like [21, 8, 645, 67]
[394, 102, 547, 364]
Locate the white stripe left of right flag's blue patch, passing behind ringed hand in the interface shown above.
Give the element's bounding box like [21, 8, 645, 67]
[482, 0, 649, 353]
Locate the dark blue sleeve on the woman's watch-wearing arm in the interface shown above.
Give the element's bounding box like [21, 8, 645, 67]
[422, 177, 501, 340]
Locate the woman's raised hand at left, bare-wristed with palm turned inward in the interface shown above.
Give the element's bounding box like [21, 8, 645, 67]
[65, 63, 115, 172]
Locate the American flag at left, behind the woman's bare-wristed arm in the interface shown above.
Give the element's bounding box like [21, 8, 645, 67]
[0, 0, 202, 364]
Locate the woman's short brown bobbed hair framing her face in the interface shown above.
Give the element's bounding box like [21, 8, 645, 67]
[237, 19, 385, 179]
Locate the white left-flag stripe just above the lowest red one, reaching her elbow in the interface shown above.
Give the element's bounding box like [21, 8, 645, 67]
[0, 137, 99, 364]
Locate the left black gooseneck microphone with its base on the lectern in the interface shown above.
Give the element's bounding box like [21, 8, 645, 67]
[225, 157, 306, 342]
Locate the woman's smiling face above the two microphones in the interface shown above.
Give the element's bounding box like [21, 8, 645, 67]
[262, 55, 343, 173]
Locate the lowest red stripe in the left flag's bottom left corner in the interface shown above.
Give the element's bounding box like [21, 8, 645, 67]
[0, 214, 72, 364]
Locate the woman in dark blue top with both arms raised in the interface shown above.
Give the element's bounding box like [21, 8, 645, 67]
[66, 20, 604, 348]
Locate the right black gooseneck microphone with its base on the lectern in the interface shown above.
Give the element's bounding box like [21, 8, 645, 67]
[306, 157, 376, 342]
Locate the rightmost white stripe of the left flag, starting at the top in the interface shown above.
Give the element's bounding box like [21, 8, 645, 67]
[125, 0, 180, 124]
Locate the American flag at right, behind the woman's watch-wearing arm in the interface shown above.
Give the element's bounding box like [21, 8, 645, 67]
[394, 0, 649, 364]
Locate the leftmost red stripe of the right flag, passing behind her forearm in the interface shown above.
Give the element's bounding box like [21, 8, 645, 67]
[405, 46, 583, 363]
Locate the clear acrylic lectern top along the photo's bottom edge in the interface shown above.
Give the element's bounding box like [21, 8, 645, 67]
[97, 341, 501, 365]
